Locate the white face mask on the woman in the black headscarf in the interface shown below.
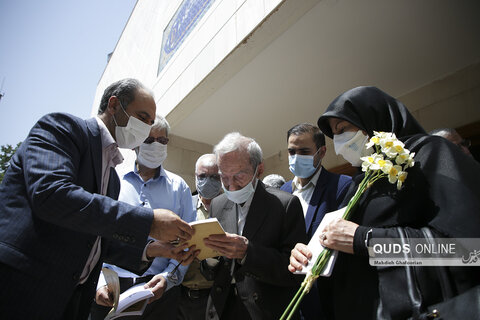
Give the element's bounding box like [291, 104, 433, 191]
[333, 130, 369, 167]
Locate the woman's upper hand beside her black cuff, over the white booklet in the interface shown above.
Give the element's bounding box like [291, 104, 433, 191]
[320, 218, 358, 254]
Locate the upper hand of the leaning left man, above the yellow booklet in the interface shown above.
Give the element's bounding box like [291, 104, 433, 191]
[150, 209, 194, 242]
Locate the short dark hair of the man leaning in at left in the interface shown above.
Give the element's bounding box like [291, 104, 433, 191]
[98, 78, 153, 114]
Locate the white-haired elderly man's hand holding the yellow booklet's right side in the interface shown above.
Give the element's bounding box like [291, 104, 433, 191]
[203, 232, 248, 259]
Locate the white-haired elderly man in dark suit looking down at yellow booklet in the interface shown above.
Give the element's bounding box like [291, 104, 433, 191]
[204, 132, 306, 320]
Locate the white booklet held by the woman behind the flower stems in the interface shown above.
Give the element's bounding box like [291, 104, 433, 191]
[295, 207, 346, 277]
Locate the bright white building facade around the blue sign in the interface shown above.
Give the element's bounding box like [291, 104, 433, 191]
[92, 0, 282, 116]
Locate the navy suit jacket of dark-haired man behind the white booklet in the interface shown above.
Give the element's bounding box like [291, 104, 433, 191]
[280, 167, 352, 240]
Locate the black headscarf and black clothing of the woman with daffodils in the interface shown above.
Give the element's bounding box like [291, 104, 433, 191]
[318, 87, 480, 319]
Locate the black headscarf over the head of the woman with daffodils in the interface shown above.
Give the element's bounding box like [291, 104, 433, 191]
[318, 87, 425, 138]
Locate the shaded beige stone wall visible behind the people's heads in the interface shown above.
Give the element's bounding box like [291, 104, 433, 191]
[165, 63, 480, 185]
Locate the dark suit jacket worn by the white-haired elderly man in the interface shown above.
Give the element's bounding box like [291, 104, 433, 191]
[207, 181, 306, 319]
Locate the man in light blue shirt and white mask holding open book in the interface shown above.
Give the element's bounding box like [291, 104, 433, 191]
[92, 115, 196, 319]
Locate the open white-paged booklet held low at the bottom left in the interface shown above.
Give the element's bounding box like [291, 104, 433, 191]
[102, 268, 153, 320]
